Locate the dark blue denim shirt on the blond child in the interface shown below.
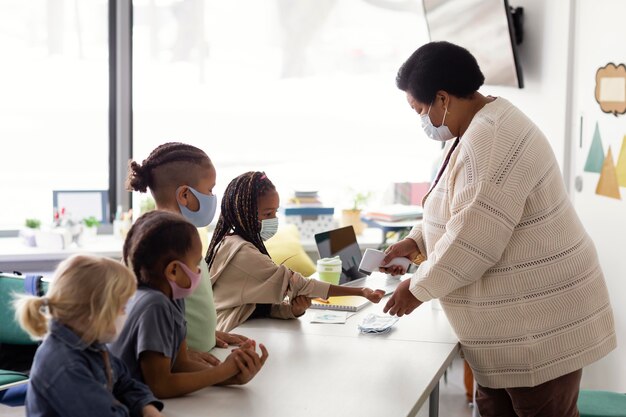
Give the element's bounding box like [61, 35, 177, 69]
[26, 320, 163, 417]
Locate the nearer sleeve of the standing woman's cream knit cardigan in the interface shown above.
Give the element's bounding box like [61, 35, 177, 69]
[410, 181, 524, 301]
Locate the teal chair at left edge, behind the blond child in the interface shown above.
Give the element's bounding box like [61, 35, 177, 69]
[0, 272, 48, 405]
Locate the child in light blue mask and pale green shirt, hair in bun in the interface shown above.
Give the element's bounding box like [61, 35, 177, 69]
[126, 142, 246, 365]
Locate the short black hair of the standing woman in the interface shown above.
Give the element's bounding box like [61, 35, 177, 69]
[396, 41, 485, 103]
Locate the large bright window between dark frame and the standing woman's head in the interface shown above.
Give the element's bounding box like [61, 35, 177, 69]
[133, 0, 440, 211]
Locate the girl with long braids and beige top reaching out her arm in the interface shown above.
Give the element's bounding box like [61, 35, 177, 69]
[206, 172, 384, 331]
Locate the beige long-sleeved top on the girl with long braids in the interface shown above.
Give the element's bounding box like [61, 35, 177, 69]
[209, 235, 329, 332]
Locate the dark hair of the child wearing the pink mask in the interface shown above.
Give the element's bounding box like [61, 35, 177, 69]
[123, 210, 198, 287]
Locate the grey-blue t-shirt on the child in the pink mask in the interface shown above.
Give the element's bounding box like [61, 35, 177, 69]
[109, 286, 187, 381]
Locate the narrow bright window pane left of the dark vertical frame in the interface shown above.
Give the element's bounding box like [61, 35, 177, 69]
[0, 0, 108, 229]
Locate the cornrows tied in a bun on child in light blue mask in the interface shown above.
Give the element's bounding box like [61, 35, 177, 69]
[126, 142, 211, 193]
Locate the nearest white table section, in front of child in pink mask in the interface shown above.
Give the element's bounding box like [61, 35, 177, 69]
[165, 329, 458, 417]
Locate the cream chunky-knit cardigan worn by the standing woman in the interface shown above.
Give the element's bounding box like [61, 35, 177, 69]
[410, 98, 616, 388]
